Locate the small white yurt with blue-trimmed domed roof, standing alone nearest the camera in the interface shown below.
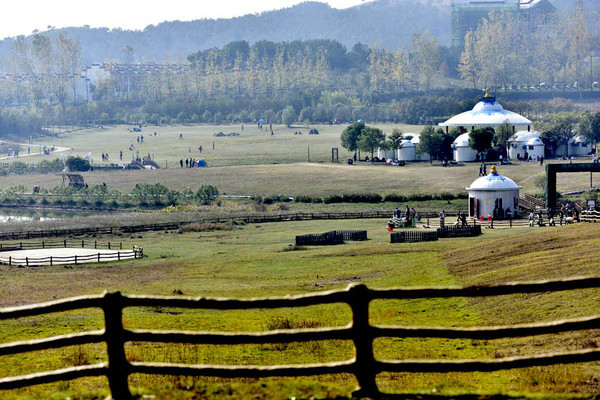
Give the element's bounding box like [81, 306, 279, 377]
[466, 165, 522, 218]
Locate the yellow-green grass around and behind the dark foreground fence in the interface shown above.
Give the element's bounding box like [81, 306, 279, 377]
[0, 220, 600, 399]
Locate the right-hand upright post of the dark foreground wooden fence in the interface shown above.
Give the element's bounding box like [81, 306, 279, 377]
[349, 284, 379, 398]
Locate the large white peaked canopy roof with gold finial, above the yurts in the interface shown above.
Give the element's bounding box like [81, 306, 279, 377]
[439, 90, 531, 127]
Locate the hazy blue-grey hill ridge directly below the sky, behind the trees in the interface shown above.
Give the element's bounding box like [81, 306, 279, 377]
[0, 0, 600, 65]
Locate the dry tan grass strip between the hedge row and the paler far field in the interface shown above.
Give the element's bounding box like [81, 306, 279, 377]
[0, 153, 600, 196]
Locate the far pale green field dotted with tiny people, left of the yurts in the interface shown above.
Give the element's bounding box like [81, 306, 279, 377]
[21, 124, 422, 168]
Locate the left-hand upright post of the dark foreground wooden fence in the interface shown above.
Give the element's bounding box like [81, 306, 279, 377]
[102, 292, 132, 400]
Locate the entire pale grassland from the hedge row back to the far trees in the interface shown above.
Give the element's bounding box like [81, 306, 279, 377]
[0, 124, 590, 196]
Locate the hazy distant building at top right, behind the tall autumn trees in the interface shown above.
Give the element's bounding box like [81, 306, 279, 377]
[450, 0, 556, 49]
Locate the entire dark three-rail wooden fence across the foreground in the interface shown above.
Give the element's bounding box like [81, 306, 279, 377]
[0, 278, 600, 400]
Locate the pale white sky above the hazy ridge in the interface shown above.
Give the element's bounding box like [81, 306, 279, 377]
[0, 0, 369, 39]
